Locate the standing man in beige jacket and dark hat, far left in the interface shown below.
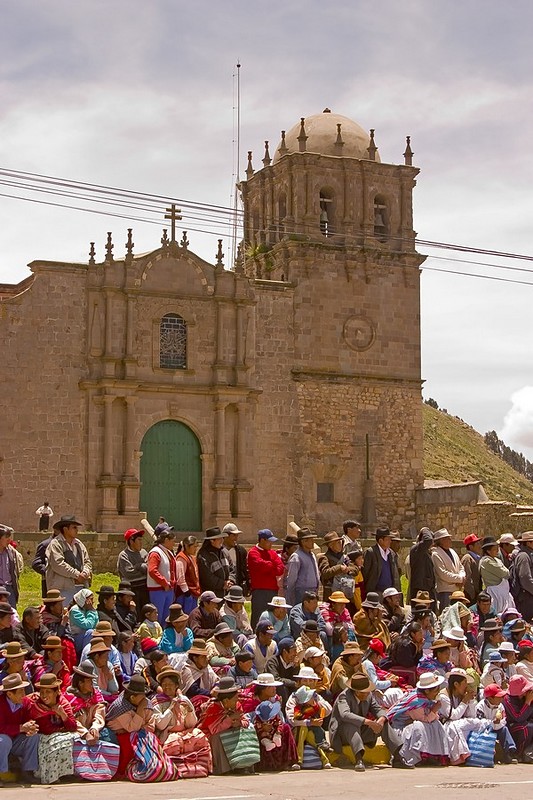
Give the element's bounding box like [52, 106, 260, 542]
[46, 515, 93, 605]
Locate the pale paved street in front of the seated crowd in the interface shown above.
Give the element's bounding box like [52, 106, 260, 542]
[2, 765, 533, 800]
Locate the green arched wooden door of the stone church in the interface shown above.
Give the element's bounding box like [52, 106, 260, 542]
[140, 420, 202, 531]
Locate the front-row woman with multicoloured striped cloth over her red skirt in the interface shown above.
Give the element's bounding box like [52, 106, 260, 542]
[106, 675, 177, 783]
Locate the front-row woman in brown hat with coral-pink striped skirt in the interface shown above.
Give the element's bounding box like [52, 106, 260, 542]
[153, 667, 213, 778]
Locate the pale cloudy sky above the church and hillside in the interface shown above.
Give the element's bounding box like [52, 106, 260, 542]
[0, 0, 533, 458]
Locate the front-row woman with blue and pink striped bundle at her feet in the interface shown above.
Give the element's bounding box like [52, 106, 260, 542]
[65, 660, 120, 781]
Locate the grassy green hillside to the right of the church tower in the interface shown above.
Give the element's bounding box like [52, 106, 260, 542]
[422, 403, 533, 505]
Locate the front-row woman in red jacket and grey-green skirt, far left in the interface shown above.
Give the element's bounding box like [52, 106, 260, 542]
[30, 672, 76, 783]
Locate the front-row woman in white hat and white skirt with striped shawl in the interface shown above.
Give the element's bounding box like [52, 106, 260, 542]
[387, 672, 449, 766]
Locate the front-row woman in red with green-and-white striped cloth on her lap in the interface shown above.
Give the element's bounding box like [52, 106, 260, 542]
[199, 677, 260, 775]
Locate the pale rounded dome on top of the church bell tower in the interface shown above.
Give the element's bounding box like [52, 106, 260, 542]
[273, 108, 380, 163]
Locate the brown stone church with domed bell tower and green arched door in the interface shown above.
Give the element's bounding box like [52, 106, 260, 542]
[0, 110, 423, 537]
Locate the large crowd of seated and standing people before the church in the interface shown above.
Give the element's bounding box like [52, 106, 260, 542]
[0, 515, 533, 784]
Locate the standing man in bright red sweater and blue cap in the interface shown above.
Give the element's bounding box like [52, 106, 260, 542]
[248, 528, 284, 630]
